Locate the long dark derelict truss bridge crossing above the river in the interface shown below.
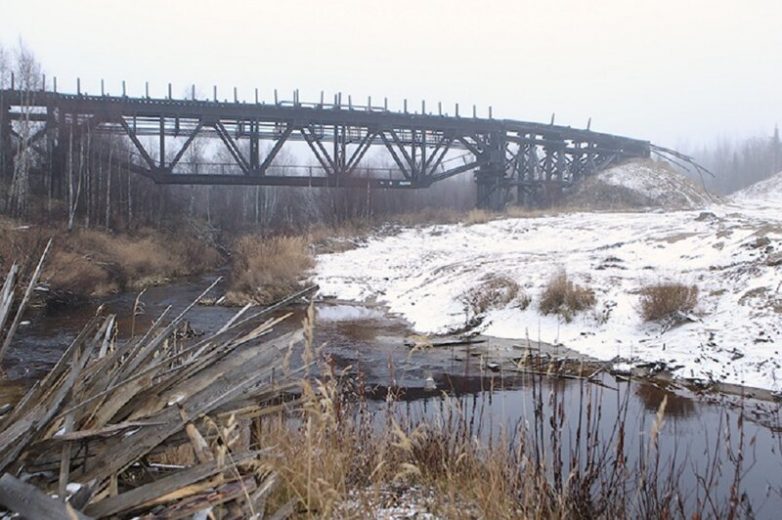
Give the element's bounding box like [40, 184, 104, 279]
[0, 89, 654, 209]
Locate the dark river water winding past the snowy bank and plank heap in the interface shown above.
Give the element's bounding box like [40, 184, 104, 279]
[0, 276, 782, 518]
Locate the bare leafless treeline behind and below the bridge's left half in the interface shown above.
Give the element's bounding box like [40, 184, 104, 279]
[0, 44, 475, 236]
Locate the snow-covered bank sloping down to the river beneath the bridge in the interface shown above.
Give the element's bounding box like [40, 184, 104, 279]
[314, 175, 782, 391]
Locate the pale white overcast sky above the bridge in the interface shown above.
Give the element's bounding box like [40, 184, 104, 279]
[0, 0, 782, 146]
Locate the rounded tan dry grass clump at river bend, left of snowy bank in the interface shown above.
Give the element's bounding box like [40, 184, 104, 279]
[226, 235, 314, 305]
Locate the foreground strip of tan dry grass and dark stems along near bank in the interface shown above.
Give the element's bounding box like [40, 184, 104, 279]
[252, 358, 752, 519]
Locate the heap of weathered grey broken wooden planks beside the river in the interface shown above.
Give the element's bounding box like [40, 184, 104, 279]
[0, 250, 315, 518]
